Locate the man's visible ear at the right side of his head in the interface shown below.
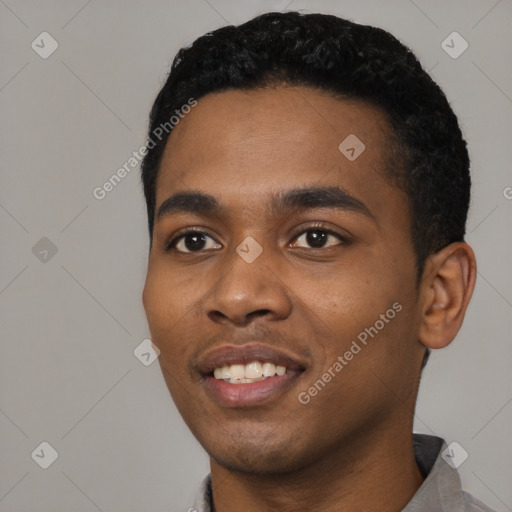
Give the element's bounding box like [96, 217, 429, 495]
[419, 242, 476, 349]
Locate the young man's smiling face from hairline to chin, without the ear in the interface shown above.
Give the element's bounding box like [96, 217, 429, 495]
[143, 86, 423, 474]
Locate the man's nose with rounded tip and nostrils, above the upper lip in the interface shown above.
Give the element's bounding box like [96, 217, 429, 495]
[203, 246, 292, 325]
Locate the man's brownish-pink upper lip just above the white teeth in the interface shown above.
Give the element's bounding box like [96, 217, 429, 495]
[198, 343, 306, 375]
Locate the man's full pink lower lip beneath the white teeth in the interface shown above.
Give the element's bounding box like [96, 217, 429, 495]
[204, 373, 300, 407]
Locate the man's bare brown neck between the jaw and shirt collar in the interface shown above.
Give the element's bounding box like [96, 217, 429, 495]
[211, 427, 423, 512]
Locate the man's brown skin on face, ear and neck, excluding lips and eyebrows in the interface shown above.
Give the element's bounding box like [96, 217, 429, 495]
[143, 85, 476, 512]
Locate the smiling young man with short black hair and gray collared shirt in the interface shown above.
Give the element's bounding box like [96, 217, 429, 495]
[142, 12, 490, 512]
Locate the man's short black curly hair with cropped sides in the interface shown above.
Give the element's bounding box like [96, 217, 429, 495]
[142, 11, 471, 279]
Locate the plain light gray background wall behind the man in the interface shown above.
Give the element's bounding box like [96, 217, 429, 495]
[0, 0, 512, 512]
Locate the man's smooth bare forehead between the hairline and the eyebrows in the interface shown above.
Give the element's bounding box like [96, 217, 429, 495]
[156, 87, 399, 216]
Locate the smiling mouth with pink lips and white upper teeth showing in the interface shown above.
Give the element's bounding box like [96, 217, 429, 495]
[200, 344, 306, 407]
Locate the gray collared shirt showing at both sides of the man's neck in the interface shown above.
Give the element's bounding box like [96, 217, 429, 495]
[189, 434, 494, 512]
